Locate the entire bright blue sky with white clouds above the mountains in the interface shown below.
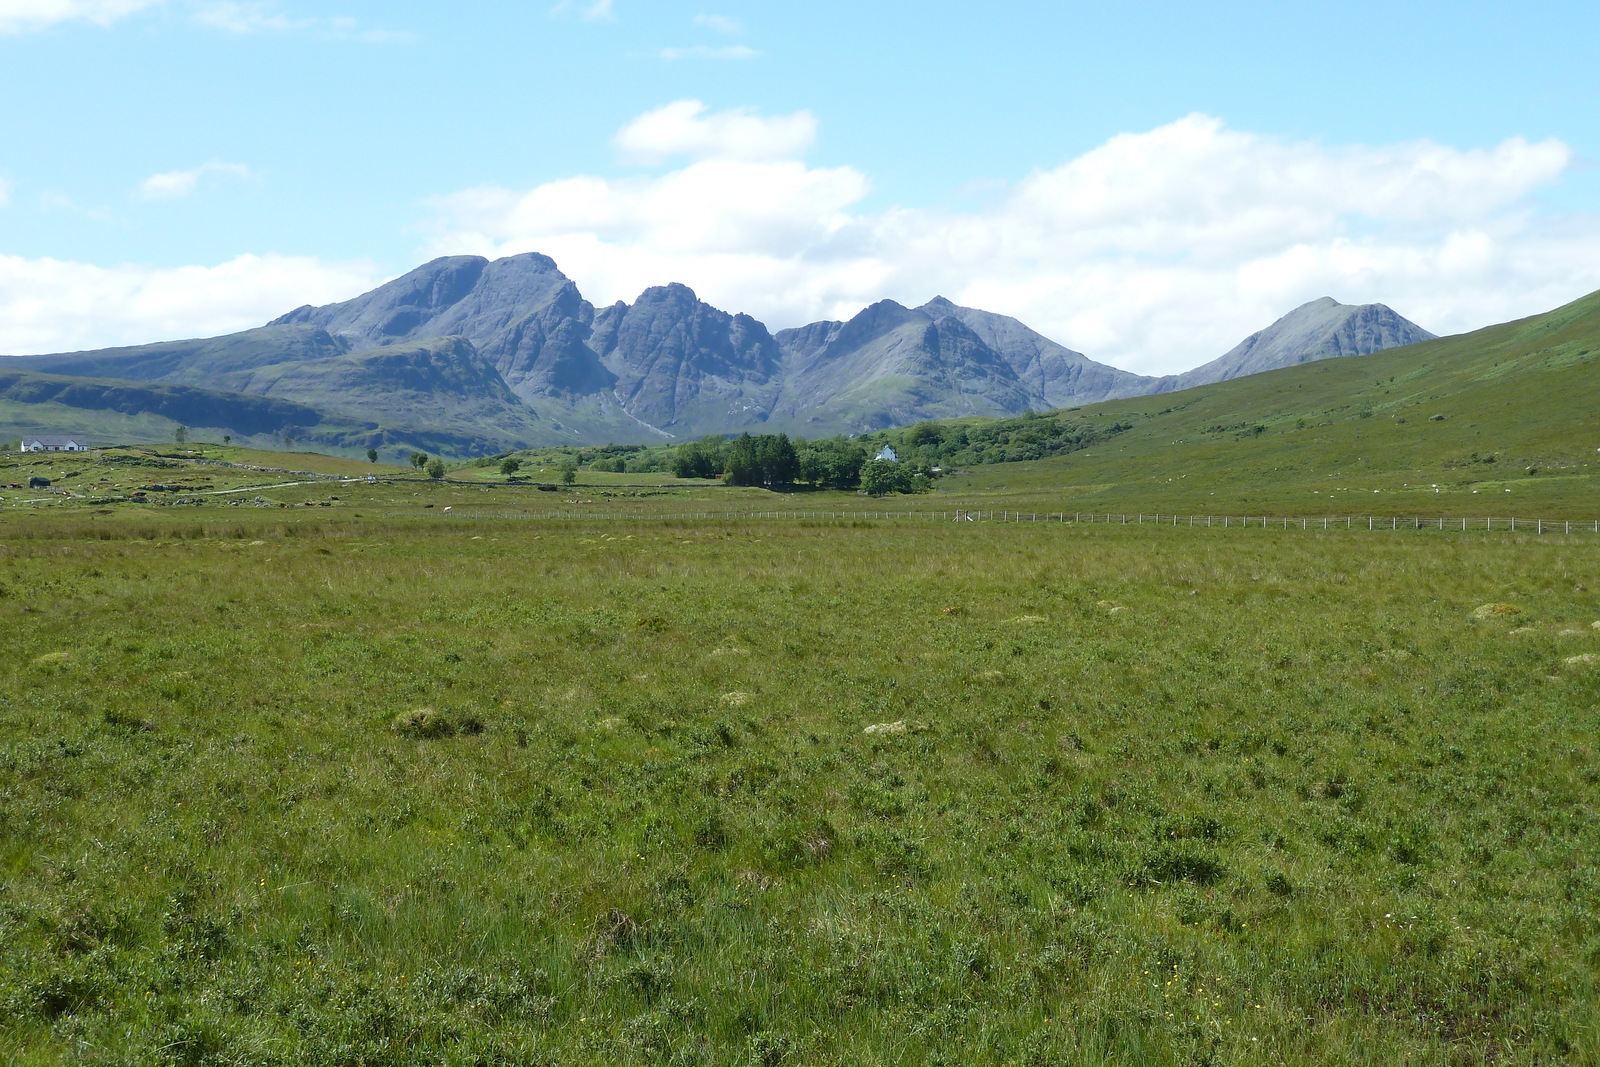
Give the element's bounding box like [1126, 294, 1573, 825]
[0, 0, 1600, 371]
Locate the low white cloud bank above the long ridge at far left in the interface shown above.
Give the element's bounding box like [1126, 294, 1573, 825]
[0, 254, 382, 355]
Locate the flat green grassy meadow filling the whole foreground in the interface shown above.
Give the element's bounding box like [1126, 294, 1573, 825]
[0, 511, 1600, 1067]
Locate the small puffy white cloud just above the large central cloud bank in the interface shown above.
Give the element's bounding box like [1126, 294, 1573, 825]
[613, 101, 816, 163]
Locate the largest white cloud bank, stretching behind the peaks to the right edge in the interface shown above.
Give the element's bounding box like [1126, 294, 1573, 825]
[419, 111, 1600, 373]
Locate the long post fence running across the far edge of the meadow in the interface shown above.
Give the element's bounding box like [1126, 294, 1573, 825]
[389, 509, 1600, 536]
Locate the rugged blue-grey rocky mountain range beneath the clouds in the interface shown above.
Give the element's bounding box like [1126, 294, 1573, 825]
[0, 253, 1434, 454]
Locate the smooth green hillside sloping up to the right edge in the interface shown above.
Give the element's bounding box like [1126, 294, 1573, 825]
[889, 293, 1600, 517]
